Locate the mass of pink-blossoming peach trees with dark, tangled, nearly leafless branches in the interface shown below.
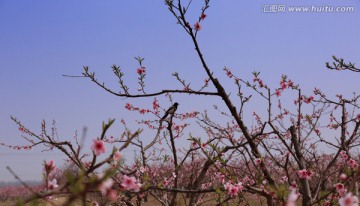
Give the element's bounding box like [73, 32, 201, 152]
[3, 0, 360, 206]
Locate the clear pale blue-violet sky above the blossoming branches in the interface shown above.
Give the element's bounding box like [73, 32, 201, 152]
[0, 0, 360, 181]
